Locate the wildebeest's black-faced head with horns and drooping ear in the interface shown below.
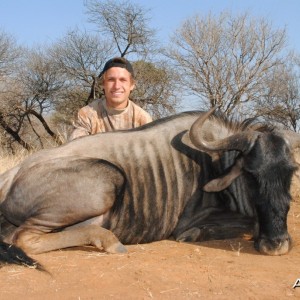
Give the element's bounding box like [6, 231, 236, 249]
[190, 109, 300, 255]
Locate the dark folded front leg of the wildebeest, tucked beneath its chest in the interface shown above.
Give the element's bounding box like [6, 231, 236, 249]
[174, 208, 255, 242]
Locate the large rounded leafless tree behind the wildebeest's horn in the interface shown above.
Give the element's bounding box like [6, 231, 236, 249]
[167, 13, 286, 115]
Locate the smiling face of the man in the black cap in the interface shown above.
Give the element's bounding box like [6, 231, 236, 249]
[103, 67, 134, 109]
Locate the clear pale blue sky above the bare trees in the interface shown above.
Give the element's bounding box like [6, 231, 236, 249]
[0, 0, 300, 110]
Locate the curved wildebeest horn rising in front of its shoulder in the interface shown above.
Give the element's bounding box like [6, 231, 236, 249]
[189, 107, 259, 152]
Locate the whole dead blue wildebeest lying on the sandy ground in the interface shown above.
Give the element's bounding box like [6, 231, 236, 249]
[0, 110, 299, 266]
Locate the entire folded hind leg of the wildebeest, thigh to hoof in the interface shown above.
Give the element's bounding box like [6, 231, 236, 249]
[1, 157, 126, 254]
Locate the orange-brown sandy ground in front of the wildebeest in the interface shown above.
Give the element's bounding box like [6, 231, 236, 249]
[0, 201, 300, 300]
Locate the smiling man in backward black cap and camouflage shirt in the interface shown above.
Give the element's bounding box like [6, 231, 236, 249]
[69, 57, 152, 140]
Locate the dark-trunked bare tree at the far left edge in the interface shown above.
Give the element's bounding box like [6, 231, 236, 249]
[0, 50, 64, 150]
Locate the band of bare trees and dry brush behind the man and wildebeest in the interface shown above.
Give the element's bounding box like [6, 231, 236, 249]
[0, 0, 300, 154]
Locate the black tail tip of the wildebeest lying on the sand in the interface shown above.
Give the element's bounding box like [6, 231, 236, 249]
[0, 241, 47, 272]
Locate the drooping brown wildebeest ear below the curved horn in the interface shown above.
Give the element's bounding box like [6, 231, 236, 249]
[203, 159, 243, 192]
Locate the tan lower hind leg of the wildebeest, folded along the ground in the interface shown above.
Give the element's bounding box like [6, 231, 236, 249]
[13, 225, 126, 254]
